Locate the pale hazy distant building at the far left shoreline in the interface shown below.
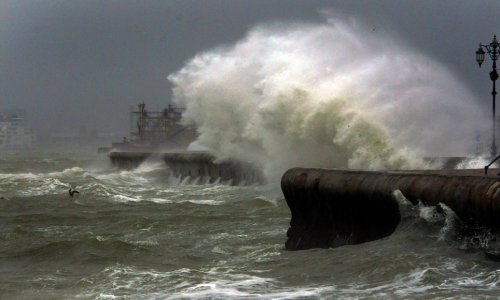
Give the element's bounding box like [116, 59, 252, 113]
[0, 112, 35, 150]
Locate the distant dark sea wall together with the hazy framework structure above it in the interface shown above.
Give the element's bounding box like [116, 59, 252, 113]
[105, 103, 264, 185]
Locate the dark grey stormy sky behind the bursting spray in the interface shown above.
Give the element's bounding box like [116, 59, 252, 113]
[0, 0, 500, 134]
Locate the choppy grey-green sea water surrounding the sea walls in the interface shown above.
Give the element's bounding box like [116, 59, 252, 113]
[0, 154, 500, 299]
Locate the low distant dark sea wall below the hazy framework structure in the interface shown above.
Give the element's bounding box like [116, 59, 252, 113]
[109, 151, 264, 185]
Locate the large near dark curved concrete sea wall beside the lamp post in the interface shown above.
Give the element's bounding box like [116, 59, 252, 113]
[281, 168, 500, 250]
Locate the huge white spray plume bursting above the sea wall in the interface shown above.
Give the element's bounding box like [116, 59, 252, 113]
[169, 21, 483, 183]
